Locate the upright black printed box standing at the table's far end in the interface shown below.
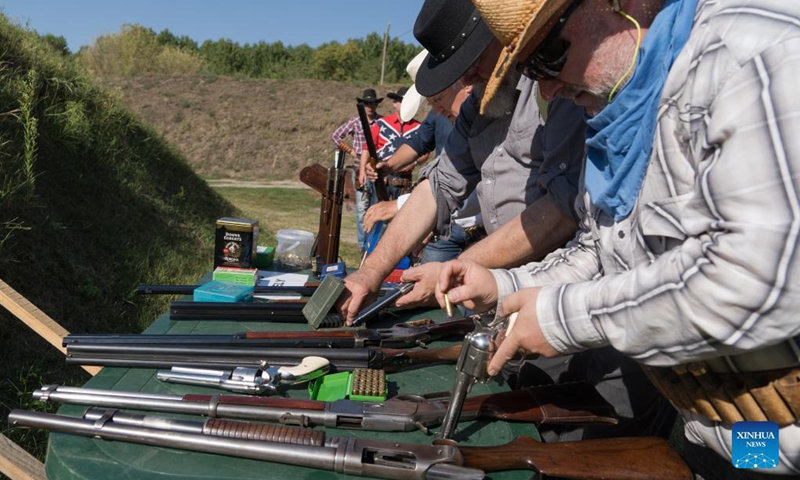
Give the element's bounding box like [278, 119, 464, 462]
[214, 217, 258, 268]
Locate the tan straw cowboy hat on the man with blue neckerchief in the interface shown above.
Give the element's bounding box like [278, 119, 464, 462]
[472, 0, 573, 111]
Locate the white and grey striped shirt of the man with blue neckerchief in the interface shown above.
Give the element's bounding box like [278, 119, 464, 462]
[493, 0, 800, 475]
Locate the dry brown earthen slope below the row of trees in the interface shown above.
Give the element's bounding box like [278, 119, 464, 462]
[100, 75, 427, 182]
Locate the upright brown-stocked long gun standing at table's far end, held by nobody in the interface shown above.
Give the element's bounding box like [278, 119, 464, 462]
[300, 149, 345, 273]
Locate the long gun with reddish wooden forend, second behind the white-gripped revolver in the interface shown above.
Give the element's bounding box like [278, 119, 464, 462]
[62, 318, 475, 348]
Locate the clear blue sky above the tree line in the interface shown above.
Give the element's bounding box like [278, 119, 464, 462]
[0, 0, 423, 52]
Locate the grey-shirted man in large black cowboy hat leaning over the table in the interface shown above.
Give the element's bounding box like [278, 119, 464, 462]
[340, 0, 674, 440]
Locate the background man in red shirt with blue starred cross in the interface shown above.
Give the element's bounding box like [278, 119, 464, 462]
[359, 87, 420, 199]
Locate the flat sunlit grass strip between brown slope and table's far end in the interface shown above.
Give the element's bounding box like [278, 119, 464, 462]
[214, 187, 361, 267]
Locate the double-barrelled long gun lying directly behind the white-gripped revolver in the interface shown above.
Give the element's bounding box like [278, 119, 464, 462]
[67, 344, 461, 373]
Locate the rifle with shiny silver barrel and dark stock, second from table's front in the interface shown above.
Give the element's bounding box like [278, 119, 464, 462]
[33, 382, 617, 433]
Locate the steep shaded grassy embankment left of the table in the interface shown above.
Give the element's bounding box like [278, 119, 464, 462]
[0, 15, 237, 455]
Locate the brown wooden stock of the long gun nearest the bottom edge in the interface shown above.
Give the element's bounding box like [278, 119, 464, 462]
[458, 437, 692, 480]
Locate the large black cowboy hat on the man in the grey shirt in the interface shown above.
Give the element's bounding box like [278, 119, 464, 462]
[414, 0, 494, 97]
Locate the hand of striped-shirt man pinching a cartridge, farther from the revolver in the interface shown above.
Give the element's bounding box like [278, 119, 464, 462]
[436, 260, 497, 312]
